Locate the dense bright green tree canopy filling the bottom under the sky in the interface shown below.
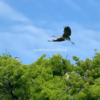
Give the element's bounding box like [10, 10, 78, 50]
[0, 49, 100, 100]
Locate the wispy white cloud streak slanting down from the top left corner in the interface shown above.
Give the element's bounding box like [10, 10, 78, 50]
[0, 1, 30, 22]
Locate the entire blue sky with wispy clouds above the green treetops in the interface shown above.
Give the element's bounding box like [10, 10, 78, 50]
[0, 0, 100, 64]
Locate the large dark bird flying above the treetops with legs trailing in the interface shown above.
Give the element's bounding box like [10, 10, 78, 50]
[48, 26, 74, 44]
